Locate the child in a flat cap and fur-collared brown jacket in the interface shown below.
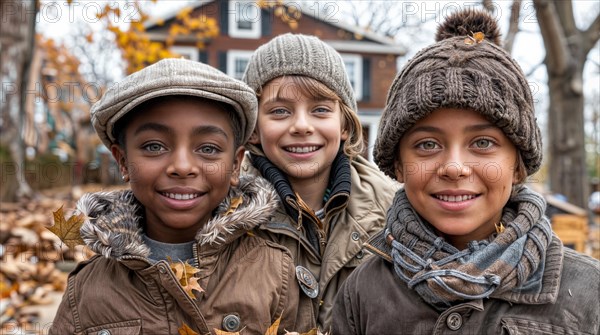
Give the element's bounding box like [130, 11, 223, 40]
[49, 59, 299, 335]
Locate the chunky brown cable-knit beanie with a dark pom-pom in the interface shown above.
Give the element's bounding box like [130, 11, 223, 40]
[373, 10, 542, 178]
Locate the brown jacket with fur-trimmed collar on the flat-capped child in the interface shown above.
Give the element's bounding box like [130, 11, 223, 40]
[49, 178, 299, 335]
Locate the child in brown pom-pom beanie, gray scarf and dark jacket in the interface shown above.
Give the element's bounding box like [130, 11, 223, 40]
[333, 11, 600, 335]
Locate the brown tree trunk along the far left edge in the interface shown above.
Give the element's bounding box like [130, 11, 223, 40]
[0, 0, 37, 201]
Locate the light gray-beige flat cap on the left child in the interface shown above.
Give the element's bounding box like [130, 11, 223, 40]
[91, 58, 257, 148]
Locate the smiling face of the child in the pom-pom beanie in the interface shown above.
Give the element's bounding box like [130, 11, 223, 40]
[396, 108, 518, 248]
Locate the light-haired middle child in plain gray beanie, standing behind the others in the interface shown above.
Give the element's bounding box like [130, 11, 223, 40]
[242, 34, 397, 331]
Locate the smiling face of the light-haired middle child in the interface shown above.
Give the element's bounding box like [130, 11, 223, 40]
[250, 77, 348, 186]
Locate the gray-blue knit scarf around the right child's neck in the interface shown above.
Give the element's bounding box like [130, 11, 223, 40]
[384, 186, 552, 310]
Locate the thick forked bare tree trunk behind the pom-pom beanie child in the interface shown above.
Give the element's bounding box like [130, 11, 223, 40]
[533, 0, 600, 207]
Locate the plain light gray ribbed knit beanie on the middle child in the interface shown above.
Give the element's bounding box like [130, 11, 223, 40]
[242, 33, 357, 112]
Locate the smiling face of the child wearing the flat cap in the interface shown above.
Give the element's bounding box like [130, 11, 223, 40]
[111, 97, 244, 243]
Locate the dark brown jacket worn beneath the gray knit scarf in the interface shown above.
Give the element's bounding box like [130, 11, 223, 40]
[332, 237, 600, 335]
